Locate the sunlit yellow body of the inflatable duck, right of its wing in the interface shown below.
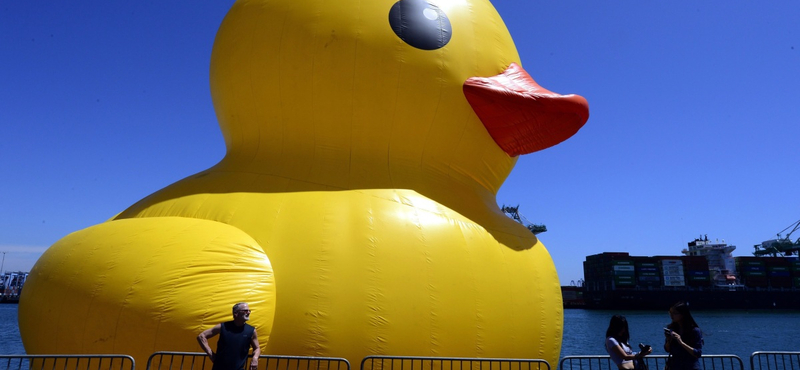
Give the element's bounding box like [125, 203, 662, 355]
[117, 173, 561, 362]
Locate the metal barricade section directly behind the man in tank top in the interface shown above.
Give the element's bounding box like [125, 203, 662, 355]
[148, 352, 350, 370]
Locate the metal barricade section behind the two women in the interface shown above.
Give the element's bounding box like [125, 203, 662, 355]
[558, 355, 748, 370]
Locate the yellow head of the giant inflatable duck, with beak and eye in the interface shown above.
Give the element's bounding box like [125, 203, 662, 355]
[211, 0, 588, 193]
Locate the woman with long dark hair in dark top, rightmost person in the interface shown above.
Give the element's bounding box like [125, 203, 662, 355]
[664, 302, 703, 370]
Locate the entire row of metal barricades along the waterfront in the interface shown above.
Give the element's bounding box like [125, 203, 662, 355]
[6, 351, 784, 370]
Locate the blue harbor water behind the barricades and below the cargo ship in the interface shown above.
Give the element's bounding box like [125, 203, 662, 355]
[0, 304, 800, 362]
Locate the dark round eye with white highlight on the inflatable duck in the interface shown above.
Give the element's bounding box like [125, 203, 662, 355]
[389, 0, 453, 50]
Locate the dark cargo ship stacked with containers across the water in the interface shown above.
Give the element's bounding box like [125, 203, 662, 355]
[562, 236, 800, 310]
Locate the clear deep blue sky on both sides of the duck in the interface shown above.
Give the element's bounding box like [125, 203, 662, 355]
[0, 0, 800, 284]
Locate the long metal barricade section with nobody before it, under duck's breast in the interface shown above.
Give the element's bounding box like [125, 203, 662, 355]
[361, 356, 550, 370]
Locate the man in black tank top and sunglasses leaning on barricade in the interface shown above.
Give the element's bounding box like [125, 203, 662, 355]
[197, 303, 261, 370]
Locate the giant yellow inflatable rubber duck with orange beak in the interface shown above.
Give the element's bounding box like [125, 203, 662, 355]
[19, 0, 588, 364]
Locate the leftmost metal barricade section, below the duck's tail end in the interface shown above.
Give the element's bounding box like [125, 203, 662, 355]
[0, 355, 136, 370]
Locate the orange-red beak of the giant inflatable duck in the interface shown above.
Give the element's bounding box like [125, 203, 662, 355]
[464, 63, 589, 157]
